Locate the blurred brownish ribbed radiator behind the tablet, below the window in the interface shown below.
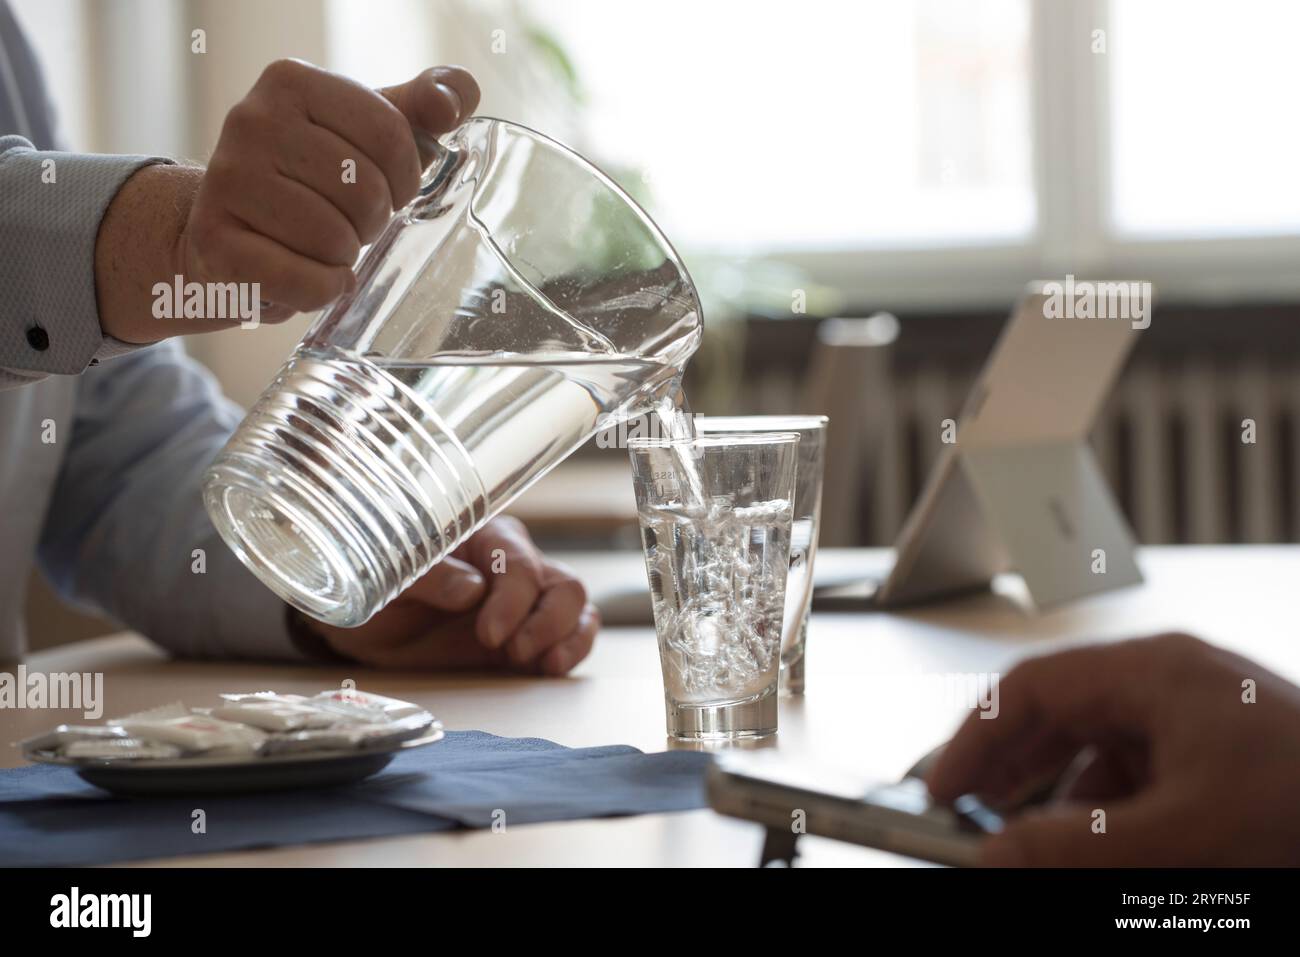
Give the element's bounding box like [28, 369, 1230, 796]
[873, 358, 1300, 545]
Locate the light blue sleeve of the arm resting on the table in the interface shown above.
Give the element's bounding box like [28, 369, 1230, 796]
[38, 342, 304, 659]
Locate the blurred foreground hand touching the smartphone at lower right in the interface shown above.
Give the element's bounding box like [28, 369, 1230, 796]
[928, 635, 1300, 866]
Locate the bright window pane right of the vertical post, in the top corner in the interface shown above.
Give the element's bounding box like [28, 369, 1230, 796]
[1109, 0, 1300, 237]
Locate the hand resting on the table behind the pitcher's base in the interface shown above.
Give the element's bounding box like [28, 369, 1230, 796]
[301, 516, 601, 675]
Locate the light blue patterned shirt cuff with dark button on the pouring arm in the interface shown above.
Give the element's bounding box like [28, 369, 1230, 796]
[0, 137, 172, 374]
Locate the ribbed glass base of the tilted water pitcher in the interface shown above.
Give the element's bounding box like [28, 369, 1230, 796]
[203, 350, 488, 627]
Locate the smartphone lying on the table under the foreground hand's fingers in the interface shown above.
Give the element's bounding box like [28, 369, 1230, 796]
[706, 752, 1002, 867]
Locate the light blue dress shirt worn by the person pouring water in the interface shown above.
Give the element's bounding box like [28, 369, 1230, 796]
[0, 0, 304, 659]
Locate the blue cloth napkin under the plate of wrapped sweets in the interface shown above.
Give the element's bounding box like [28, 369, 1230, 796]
[0, 731, 710, 867]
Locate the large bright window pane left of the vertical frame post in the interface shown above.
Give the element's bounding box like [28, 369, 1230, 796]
[529, 0, 1035, 250]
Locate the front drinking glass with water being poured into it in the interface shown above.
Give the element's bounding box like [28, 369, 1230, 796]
[628, 432, 800, 739]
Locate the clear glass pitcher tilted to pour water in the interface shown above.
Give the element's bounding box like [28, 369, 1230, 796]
[203, 118, 701, 627]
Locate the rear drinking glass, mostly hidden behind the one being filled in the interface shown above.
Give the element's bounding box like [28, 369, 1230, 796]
[696, 415, 829, 694]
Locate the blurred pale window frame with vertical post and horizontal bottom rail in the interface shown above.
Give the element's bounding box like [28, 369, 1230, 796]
[711, 0, 1300, 309]
